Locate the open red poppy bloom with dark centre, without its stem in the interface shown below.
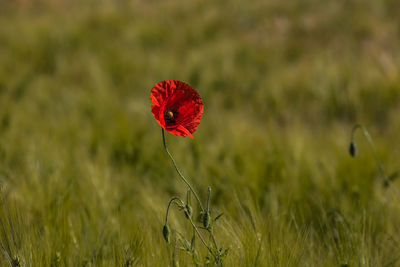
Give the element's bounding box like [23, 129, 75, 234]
[150, 80, 204, 138]
